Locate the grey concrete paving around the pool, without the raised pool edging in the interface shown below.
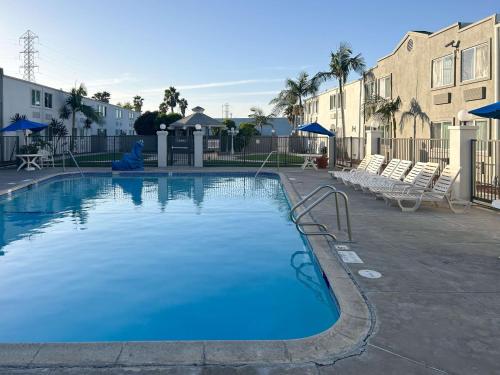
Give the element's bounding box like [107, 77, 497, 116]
[0, 169, 500, 375]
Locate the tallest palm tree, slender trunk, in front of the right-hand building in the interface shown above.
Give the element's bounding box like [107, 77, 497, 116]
[313, 42, 365, 137]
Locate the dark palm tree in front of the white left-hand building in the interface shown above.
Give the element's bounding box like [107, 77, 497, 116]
[59, 84, 102, 150]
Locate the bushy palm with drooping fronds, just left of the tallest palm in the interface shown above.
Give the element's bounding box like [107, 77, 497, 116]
[269, 72, 319, 129]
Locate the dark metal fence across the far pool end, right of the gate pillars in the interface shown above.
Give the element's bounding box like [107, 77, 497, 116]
[203, 134, 328, 167]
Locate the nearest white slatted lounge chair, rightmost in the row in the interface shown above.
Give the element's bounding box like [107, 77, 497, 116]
[384, 165, 470, 213]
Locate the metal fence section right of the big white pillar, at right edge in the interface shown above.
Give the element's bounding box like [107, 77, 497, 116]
[471, 140, 500, 204]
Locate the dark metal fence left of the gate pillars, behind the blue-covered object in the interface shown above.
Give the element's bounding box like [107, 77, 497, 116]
[28, 135, 158, 167]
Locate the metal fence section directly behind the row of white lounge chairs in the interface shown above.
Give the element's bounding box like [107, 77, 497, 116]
[377, 138, 450, 177]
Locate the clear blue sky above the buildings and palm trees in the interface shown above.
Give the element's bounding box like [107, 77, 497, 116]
[0, 0, 500, 117]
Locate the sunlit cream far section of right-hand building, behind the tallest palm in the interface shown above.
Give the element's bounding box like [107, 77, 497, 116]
[304, 79, 364, 137]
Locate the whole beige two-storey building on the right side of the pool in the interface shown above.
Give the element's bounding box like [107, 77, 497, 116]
[305, 15, 500, 140]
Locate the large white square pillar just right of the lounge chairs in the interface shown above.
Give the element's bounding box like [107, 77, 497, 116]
[448, 126, 479, 201]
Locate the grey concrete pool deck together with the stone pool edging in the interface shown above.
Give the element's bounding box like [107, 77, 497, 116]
[0, 168, 500, 374]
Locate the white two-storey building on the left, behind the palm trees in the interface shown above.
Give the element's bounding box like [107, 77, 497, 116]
[0, 68, 140, 136]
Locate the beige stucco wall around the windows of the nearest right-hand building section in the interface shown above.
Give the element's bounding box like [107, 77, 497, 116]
[372, 16, 498, 138]
